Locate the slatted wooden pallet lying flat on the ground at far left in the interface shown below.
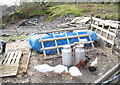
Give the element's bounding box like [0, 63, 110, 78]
[0, 51, 22, 77]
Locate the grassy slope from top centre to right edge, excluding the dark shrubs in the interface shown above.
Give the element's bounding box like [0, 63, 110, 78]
[48, 4, 120, 20]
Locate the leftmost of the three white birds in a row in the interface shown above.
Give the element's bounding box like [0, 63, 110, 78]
[33, 64, 53, 77]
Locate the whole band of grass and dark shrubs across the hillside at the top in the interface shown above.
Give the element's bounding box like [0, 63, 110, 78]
[3, 2, 120, 24]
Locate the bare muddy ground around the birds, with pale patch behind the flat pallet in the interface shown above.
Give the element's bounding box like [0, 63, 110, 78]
[2, 40, 118, 83]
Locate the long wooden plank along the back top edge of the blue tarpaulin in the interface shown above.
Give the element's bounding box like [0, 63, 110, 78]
[40, 34, 91, 42]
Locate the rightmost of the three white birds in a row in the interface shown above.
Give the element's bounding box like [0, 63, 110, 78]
[69, 66, 82, 79]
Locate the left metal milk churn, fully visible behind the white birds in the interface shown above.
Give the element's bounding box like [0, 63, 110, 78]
[62, 45, 72, 66]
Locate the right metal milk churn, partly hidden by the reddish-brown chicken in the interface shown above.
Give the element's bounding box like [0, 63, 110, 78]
[75, 44, 85, 64]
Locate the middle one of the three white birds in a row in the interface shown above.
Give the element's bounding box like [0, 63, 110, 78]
[53, 65, 68, 76]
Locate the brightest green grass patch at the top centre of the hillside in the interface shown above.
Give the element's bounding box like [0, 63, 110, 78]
[48, 4, 91, 20]
